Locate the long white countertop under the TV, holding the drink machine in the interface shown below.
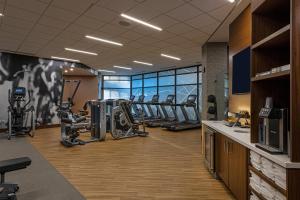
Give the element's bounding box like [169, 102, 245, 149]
[202, 121, 300, 168]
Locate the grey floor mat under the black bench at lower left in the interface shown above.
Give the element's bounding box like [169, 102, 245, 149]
[0, 133, 85, 200]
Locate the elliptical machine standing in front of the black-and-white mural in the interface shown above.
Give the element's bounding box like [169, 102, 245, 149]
[8, 87, 36, 140]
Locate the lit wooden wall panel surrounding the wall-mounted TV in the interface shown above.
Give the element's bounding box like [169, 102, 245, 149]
[228, 5, 251, 112]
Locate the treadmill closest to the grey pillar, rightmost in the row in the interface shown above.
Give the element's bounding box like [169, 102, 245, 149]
[163, 94, 201, 131]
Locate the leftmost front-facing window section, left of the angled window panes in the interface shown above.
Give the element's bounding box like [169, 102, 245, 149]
[103, 76, 130, 99]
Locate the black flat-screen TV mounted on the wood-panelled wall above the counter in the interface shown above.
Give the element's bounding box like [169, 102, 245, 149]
[232, 47, 250, 94]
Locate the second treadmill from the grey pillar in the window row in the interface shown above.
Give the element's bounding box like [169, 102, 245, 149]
[145, 95, 178, 127]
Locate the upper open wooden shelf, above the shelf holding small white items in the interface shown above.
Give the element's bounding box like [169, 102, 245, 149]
[252, 25, 290, 49]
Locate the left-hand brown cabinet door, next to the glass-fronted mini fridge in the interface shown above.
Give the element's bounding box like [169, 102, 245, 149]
[215, 133, 228, 185]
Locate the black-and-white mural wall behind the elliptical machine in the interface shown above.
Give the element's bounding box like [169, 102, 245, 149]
[0, 53, 92, 128]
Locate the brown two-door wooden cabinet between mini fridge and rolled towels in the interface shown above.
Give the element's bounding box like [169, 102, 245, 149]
[215, 133, 248, 200]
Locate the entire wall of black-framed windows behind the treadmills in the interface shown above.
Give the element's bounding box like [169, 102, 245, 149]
[102, 66, 202, 120]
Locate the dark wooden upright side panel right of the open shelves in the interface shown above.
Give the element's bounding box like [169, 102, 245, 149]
[290, 0, 300, 161]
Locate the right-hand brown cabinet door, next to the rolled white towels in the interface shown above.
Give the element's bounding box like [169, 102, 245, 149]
[228, 139, 248, 200]
